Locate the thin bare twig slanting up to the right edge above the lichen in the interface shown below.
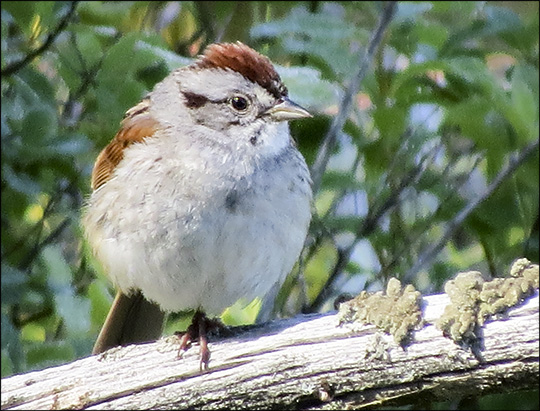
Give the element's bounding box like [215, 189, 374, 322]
[403, 140, 540, 283]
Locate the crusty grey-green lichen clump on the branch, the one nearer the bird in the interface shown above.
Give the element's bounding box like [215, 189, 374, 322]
[338, 278, 422, 346]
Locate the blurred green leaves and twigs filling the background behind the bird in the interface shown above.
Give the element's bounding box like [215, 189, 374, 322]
[1, 1, 539, 409]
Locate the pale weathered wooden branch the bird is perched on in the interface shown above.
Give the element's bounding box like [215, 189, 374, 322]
[2, 292, 539, 409]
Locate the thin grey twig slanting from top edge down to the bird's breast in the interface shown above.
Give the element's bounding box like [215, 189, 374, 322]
[311, 1, 396, 192]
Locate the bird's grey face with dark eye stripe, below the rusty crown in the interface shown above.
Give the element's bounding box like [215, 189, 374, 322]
[168, 68, 290, 157]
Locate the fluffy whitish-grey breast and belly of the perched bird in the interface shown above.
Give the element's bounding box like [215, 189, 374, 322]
[83, 132, 311, 315]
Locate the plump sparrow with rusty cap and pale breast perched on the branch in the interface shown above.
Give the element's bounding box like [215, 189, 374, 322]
[82, 42, 313, 369]
